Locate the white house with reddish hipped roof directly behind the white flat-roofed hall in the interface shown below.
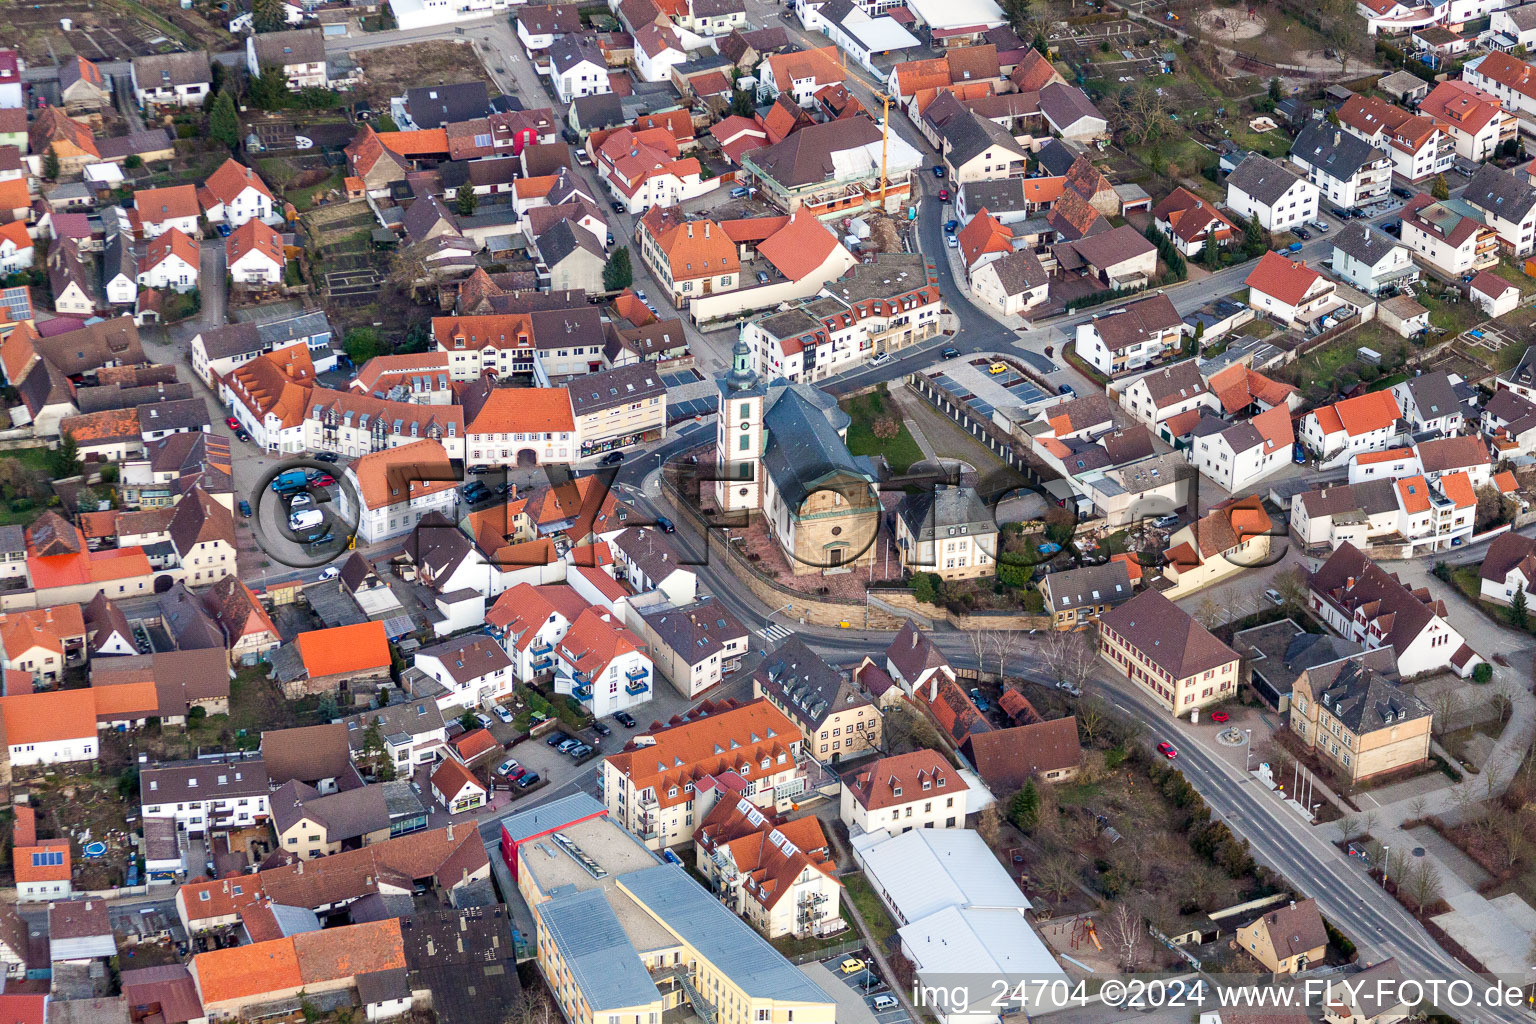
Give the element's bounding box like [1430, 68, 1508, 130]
[839, 751, 972, 835]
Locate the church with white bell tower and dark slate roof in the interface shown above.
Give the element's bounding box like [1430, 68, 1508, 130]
[714, 339, 880, 576]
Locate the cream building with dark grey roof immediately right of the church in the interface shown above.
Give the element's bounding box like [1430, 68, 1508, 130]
[895, 484, 997, 580]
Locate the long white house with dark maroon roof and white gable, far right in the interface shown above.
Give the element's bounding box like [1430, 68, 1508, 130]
[1307, 542, 1482, 679]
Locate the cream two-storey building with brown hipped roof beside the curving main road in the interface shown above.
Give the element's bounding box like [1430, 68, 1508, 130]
[1098, 590, 1240, 715]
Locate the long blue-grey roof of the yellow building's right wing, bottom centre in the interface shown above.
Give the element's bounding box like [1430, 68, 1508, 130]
[619, 864, 831, 1006]
